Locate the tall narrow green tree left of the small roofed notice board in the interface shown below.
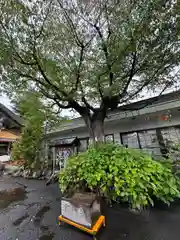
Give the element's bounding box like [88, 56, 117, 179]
[12, 93, 45, 165]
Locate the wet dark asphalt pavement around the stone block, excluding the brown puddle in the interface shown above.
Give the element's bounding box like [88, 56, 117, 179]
[0, 177, 180, 240]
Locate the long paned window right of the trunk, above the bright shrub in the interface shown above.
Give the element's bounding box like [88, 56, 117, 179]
[120, 126, 180, 160]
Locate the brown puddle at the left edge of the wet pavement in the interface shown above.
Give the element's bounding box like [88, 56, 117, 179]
[0, 187, 26, 209]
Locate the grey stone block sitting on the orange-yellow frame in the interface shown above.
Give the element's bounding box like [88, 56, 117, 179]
[61, 193, 101, 229]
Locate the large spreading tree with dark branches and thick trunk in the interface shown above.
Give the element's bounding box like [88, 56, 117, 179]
[0, 0, 180, 140]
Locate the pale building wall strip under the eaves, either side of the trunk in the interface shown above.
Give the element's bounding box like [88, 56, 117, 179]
[47, 109, 180, 142]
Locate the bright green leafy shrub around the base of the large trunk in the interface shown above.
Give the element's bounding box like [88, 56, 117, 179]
[59, 144, 180, 209]
